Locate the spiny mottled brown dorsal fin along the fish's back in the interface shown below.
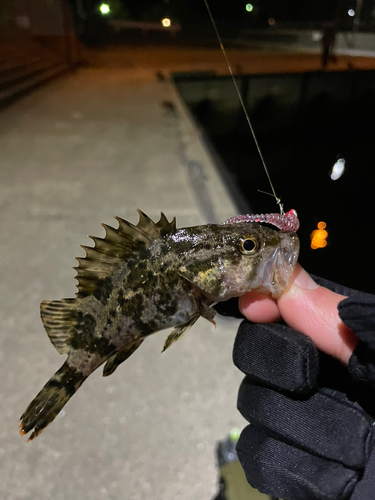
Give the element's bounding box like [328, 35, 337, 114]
[74, 210, 176, 298]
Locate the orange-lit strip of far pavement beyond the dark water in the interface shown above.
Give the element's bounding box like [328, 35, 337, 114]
[82, 41, 375, 75]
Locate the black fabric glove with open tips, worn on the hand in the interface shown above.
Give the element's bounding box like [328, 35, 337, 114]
[233, 277, 375, 500]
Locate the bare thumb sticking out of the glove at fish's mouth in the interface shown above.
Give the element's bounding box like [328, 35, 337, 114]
[277, 265, 358, 364]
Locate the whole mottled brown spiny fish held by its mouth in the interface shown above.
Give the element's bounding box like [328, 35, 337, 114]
[20, 210, 299, 441]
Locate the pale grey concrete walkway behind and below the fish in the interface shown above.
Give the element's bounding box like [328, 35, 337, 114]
[0, 69, 253, 500]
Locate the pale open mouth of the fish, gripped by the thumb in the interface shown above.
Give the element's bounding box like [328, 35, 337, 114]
[262, 233, 299, 299]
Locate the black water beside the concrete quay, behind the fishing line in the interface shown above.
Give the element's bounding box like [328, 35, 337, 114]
[178, 68, 375, 292]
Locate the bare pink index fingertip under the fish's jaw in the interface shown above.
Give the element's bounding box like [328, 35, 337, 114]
[238, 291, 281, 323]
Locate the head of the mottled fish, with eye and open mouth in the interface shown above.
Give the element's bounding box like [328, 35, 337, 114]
[178, 222, 299, 302]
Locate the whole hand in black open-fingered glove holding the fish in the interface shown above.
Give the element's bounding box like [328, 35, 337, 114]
[233, 267, 375, 500]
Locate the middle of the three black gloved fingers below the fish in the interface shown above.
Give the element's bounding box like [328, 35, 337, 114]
[237, 377, 374, 470]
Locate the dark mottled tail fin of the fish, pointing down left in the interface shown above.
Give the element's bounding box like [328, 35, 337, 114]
[20, 362, 87, 441]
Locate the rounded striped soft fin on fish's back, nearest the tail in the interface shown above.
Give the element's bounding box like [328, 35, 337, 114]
[40, 299, 79, 354]
